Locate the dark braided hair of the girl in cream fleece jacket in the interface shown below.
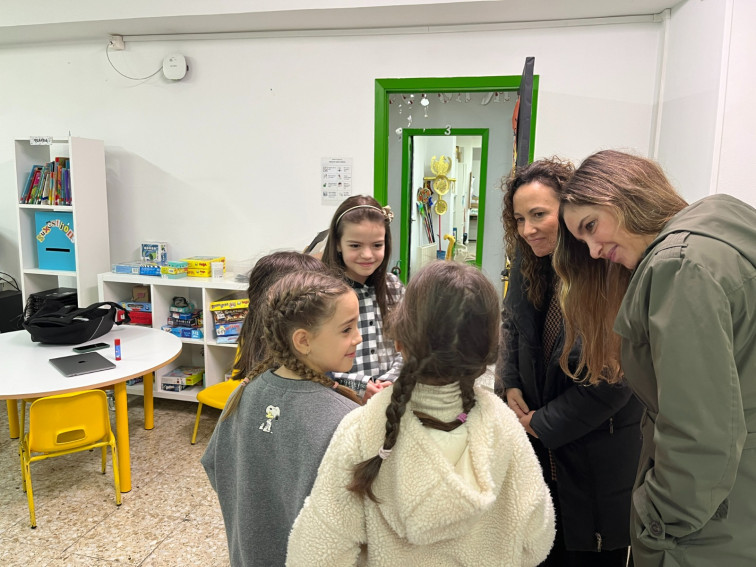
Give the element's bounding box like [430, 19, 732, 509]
[348, 261, 500, 502]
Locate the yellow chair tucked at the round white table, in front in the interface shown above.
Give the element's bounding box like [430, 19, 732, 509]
[21, 390, 121, 529]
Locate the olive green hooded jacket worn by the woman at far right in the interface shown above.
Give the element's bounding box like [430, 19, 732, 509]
[614, 195, 756, 567]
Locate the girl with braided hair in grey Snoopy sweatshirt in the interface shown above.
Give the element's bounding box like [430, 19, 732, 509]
[202, 271, 362, 567]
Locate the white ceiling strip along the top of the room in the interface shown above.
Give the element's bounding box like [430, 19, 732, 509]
[0, 0, 688, 48]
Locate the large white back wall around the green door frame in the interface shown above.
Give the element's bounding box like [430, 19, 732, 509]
[0, 24, 661, 288]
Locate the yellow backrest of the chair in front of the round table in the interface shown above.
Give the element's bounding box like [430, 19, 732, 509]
[28, 390, 110, 453]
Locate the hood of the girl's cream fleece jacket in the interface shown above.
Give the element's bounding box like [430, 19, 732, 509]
[365, 389, 511, 545]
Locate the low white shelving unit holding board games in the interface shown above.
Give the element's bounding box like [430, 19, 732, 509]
[97, 272, 247, 402]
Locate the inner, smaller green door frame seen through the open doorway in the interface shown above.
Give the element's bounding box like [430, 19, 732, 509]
[402, 128, 489, 283]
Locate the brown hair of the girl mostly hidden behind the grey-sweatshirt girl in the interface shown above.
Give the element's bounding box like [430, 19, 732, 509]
[234, 251, 324, 378]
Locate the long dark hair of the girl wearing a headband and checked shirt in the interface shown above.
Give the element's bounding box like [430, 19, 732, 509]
[322, 195, 399, 316]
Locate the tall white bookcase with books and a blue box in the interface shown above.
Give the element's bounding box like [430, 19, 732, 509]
[15, 138, 110, 306]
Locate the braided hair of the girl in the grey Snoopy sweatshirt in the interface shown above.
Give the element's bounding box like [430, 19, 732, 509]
[224, 271, 362, 419]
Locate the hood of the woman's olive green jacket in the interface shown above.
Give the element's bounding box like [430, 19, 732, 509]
[649, 194, 756, 266]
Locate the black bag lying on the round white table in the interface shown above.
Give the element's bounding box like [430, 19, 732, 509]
[23, 301, 131, 345]
